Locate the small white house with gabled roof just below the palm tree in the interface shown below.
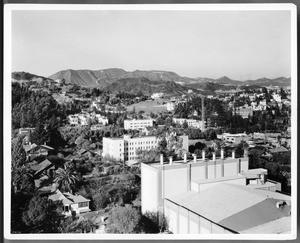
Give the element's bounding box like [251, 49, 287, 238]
[49, 189, 91, 216]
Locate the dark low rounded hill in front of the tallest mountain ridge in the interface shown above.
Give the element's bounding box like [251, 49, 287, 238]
[105, 77, 197, 95]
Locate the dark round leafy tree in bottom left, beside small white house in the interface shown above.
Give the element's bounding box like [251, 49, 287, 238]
[22, 195, 62, 233]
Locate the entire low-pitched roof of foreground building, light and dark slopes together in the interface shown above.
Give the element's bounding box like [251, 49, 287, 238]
[167, 183, 290, 232]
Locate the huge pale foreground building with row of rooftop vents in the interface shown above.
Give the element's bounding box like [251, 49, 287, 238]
[141, 150, 291, 234]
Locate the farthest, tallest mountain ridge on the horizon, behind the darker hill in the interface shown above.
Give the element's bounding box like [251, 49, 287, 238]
[49, 68, 291, 89]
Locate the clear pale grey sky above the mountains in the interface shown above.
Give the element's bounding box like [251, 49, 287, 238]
[12, 10, 291, 80]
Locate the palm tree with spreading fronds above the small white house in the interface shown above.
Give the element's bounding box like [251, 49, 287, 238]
[54, 163, 79, 193]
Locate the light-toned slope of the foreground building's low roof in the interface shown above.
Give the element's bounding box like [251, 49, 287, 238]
[167, 183, 290, 226]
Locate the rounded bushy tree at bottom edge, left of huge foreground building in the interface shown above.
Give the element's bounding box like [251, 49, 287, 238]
[106, 205, 141, 234]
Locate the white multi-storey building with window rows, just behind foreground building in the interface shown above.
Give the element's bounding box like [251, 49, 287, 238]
[102, 135, 188, 161]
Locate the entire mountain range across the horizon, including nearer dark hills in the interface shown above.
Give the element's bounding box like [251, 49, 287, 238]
[12, 68, 291, 94]
